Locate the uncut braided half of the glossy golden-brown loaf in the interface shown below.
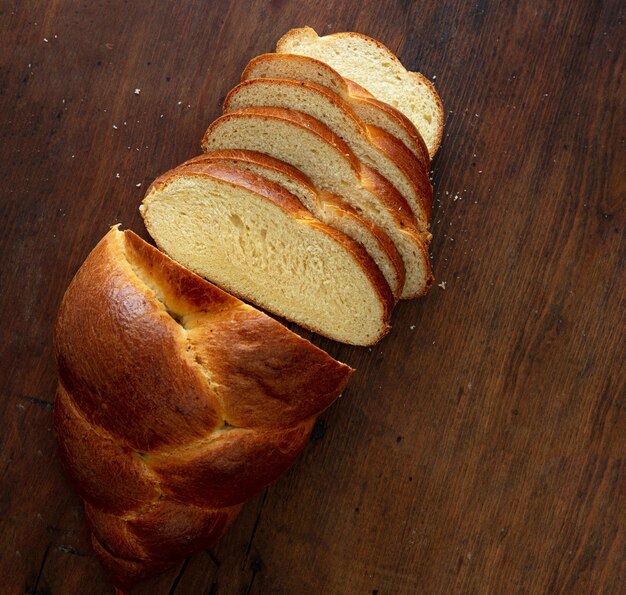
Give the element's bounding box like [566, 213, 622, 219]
[55, 228, 352, 588]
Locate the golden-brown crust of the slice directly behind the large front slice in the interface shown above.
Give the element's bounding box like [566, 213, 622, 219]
[179, 149, 406, 300]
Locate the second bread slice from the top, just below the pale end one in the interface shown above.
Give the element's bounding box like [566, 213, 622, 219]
[241, 54, 430, 170]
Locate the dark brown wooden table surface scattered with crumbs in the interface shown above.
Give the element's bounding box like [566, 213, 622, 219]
[0, 0, 626, 595]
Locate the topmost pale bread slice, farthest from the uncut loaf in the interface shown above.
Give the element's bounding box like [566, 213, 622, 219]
[276, 27, 443, 158]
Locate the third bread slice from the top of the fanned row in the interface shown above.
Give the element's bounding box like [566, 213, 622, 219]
[224, 78, 432, 230]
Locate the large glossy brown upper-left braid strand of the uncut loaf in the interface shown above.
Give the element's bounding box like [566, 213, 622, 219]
[56, 232, 219, 451]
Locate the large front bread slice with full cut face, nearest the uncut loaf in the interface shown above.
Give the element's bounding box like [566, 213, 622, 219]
[141, 163, 394, 345]
